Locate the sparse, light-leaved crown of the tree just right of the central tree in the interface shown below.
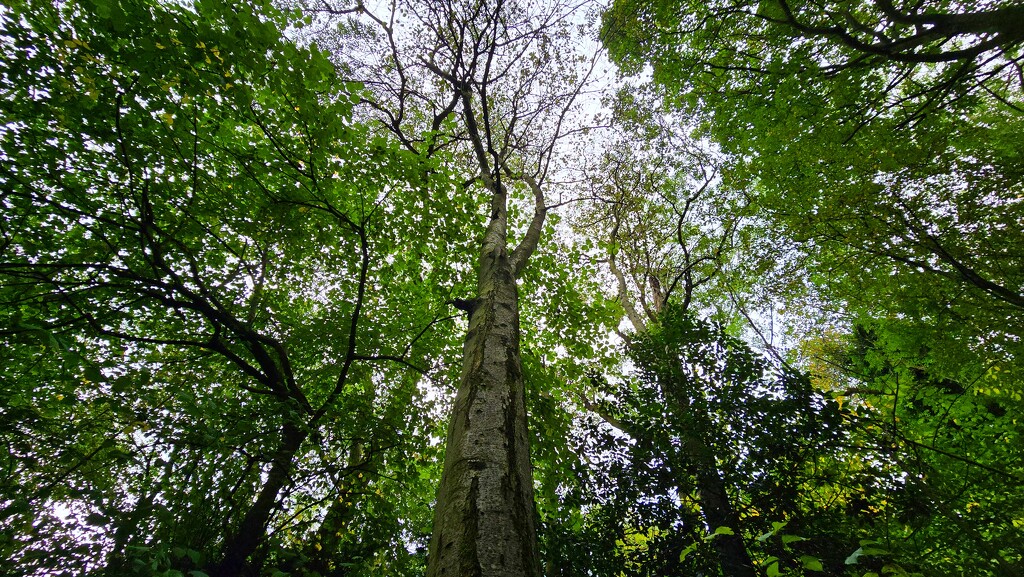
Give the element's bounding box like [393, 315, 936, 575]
[577, 91, 744, 332]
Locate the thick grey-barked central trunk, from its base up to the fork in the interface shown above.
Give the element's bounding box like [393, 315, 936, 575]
[427, 236, 540, 577]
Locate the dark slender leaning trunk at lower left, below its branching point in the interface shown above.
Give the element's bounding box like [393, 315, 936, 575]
[210, 421, 307, 577]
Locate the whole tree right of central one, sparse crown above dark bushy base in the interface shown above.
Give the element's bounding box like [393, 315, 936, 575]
[579, 104, 839, 576]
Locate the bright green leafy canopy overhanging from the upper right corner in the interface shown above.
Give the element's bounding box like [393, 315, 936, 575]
[604, 2, 1024, 414]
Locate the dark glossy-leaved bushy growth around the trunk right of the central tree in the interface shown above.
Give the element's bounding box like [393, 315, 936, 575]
[606, 311, 845, 575]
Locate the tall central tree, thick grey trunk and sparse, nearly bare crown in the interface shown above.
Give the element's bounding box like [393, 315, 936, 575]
[308, 1, 594, 576]
